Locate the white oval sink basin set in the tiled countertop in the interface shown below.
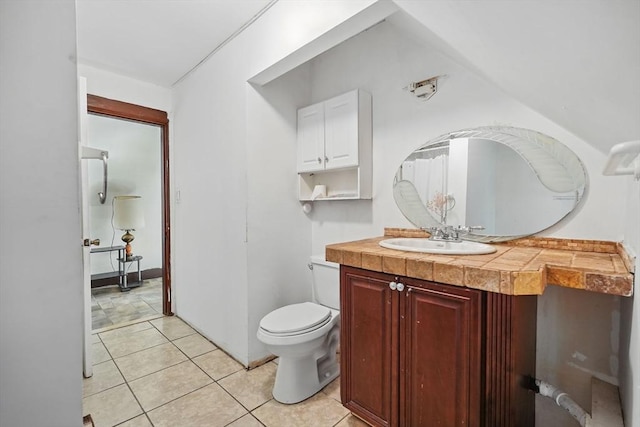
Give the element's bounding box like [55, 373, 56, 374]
[379, 237, 496, 255]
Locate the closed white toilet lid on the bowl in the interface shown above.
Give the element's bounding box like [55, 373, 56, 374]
[260, 302, 331, 334]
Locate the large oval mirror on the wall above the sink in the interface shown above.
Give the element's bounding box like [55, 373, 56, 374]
[393, 127, 587, 242]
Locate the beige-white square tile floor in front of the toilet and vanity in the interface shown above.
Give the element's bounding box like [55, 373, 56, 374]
[83, 317, 366, 427]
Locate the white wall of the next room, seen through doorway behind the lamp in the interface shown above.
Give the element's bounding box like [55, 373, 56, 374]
[87, 114, 163, 274]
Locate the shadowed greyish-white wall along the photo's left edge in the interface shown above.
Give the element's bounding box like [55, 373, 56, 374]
[0, 0, 83, 427]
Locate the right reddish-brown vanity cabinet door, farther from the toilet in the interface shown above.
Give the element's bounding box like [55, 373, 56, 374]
[400, 279, 483, 427]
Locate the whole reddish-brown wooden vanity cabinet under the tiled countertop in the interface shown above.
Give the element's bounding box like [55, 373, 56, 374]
[340, 266, 536, 427]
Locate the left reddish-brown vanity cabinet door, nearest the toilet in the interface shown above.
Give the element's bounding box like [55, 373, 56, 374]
[340, 266, 399, 426]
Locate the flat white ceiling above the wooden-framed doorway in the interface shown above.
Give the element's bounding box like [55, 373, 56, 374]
[76, 0, 273, 87]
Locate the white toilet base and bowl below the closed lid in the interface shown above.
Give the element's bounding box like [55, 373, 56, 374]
[273, 328, 340, 404]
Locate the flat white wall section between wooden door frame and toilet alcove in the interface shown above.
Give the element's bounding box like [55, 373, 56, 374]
[173, 35, 249, 363]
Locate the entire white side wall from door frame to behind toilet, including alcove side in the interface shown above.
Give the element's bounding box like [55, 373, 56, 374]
[173, 1, 379, 364]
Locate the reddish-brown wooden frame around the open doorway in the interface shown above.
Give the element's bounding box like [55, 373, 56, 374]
[87, 94, 173, 316]
